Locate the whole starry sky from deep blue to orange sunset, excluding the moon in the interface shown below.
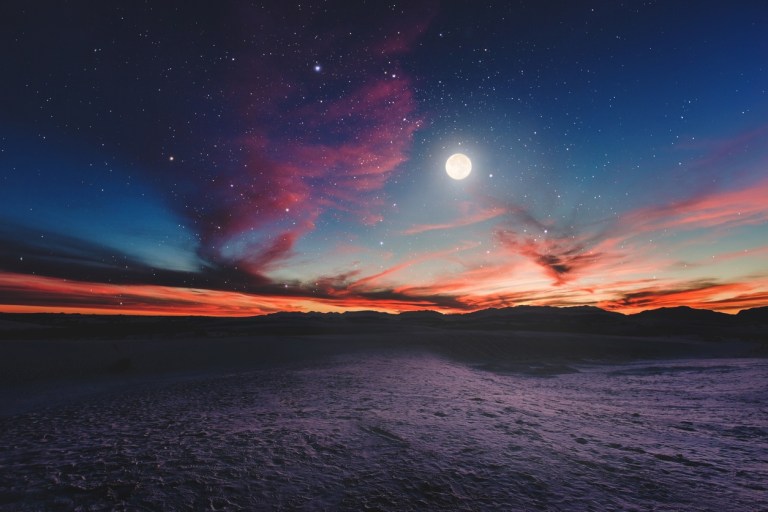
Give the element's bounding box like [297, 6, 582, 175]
[0, 0, 768, 315]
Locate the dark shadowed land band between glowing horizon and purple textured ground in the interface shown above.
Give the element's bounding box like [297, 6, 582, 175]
[0, 306, 768, 383]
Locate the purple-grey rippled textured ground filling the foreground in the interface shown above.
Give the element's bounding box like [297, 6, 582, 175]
[0, 352, 768, 511]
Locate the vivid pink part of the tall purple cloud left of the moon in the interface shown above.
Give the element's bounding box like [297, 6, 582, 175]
[195, 33, 423, 274]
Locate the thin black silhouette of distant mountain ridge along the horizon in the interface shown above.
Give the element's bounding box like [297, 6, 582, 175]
[0, 306, 768, 340]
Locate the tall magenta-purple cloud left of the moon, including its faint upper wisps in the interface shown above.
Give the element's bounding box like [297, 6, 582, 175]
[174, 6, 434, 275]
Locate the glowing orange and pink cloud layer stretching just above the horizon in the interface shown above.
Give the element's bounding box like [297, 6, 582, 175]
[6, 158, 768, 315]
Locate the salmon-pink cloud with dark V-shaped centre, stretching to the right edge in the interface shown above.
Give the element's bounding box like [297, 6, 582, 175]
[488, 166, 768, 286]
